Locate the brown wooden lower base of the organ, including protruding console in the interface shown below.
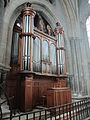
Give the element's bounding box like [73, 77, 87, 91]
[7, 72, 71, 112]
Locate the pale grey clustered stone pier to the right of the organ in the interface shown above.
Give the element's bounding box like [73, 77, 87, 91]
[70, 34, 89, 96]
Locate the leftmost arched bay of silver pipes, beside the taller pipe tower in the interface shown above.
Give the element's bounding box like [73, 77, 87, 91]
[33, 37, 40, 72]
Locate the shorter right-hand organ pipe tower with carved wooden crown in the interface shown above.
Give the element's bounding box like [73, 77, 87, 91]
[55, 23, 66, 74]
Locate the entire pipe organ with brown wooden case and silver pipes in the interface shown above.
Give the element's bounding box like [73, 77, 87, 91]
[7, 3, 71, 111]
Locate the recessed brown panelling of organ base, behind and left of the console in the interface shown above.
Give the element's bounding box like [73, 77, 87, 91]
[32, 75, 66, 106]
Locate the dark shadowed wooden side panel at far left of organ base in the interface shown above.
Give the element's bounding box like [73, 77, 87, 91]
[6, 69, 20, 108]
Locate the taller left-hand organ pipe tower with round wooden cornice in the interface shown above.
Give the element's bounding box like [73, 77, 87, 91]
[21, 3, 35, 70]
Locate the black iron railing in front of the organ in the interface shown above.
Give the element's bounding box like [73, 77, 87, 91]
[1, 98, 90, 120]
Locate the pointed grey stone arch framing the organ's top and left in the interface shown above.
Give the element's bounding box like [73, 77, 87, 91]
[1, 0, 57, 69]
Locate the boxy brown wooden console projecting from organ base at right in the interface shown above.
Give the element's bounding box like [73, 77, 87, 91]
[47, 88, 71, 107]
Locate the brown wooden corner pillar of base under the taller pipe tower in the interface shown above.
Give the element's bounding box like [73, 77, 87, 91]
[20, 77, 32, 111]
